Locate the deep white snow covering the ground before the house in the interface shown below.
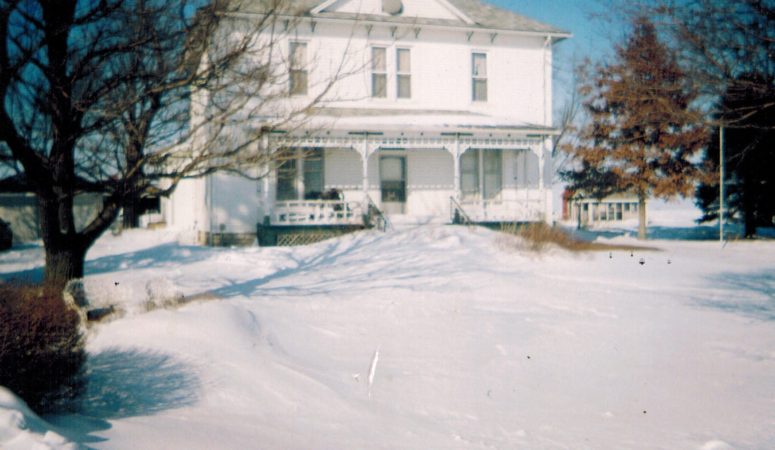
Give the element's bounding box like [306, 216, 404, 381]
[0, 224, 775, 450]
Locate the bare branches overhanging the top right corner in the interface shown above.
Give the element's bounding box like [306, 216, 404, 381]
[609, 0, 775, 128]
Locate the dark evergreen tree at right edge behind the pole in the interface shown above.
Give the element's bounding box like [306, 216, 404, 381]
[696, 74, 775, 238]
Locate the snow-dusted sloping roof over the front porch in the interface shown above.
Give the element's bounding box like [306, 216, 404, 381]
[296, 107, 558, 138]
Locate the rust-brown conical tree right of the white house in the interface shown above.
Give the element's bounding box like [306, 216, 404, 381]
[563, 17, 706, 239]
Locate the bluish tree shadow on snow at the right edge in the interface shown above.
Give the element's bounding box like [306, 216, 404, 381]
[698, 268, 775, 321]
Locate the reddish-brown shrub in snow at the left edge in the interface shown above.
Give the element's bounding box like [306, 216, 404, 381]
[0, 284, 86, 412]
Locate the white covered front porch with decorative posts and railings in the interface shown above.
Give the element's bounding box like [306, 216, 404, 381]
[260, 112, 553, 226]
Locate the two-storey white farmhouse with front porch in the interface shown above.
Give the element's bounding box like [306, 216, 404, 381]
[164, 0, 569, 244]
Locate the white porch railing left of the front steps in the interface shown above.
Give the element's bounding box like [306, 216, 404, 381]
[272, 200, 363, 225]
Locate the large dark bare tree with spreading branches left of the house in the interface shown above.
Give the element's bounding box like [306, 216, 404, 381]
[0, 0, 344, 284]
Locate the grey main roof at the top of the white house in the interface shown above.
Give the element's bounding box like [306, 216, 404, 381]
[239, 0, 570, 37]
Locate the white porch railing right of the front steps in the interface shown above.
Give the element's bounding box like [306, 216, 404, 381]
[460, 198, 545, 222]
